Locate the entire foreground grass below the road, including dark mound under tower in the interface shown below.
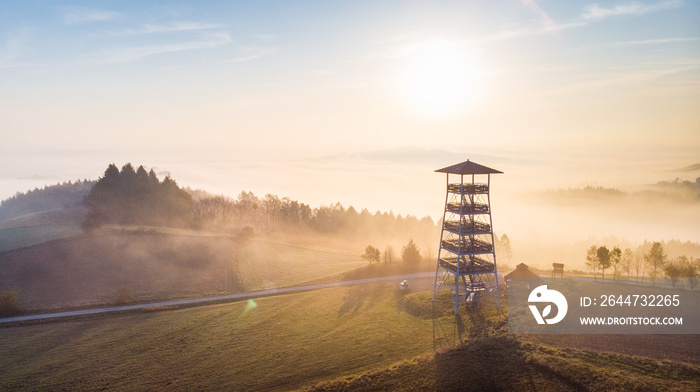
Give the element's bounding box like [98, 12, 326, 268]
[0, 282, 700, 392]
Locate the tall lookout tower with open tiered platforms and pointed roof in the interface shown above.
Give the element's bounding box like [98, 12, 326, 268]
[433, 160, 503, 314]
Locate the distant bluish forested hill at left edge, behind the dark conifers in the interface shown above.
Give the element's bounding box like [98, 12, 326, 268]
[0, 180, 95, 220]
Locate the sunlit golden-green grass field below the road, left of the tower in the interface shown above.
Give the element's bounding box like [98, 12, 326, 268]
[0, 283, 440, 390]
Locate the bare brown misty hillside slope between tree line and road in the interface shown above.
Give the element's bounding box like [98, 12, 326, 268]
[0, 228, 366, 309]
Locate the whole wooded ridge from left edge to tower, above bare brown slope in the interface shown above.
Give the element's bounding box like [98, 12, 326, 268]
[0, 163, 438, 253]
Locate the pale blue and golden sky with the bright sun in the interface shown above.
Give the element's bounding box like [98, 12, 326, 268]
[0, 0, 700, 243]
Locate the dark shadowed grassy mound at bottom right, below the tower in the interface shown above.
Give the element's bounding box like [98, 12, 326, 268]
[304, 334, 700, 392]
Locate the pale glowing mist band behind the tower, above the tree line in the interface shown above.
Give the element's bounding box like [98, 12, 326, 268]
[2, 155, 700, 278]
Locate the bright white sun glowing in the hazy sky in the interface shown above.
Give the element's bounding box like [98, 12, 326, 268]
[398, 43, 481, 116]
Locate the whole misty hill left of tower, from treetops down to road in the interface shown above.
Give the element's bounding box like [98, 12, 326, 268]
[0, 163, 435, 312]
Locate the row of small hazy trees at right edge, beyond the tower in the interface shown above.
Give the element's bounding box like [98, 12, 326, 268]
[586, 242, 700, 289]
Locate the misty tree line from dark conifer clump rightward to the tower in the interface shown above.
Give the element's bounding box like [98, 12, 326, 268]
[84, 163, 436, 242]
